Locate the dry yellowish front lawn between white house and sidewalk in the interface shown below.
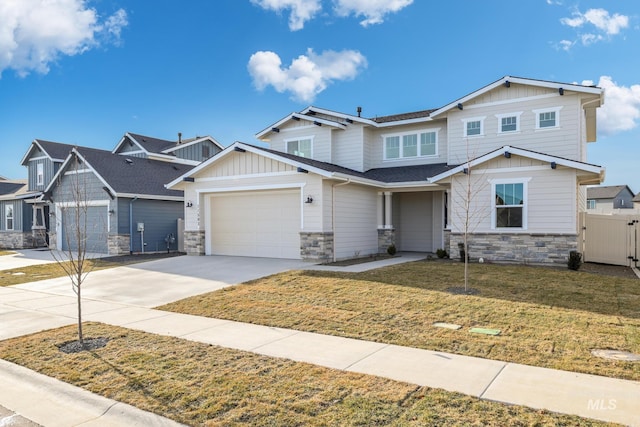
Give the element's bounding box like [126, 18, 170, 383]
[160, 261, 640, 380]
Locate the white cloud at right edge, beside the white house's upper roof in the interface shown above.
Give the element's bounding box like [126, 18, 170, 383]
[582, 76, 640, 135]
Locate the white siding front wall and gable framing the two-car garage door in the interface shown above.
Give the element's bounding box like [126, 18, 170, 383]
[182, 152, 324, 231]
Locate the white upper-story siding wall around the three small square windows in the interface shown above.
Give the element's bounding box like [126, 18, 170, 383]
[447, 89, 584, 165]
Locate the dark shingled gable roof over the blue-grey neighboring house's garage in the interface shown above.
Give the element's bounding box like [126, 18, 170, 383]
[45, 147, 192, 200]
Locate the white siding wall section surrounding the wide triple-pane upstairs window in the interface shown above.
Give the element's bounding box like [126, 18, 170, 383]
[365, 120, 448, 170]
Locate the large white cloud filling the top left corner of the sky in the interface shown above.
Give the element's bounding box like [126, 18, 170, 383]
[0, 0, 127, 77]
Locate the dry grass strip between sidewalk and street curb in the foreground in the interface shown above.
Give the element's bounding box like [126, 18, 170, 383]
[0, 323, 607, 426]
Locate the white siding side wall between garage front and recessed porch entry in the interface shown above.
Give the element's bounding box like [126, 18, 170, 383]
[333, 184, 378, 259]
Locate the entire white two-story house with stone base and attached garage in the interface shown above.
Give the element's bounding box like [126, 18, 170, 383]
[168, 76, 604, 263]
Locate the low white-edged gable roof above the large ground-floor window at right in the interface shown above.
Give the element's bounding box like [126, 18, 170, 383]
[429, 145, 604, 185]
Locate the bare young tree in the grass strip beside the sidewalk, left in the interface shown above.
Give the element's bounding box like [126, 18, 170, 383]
[49, 152, 102, 348]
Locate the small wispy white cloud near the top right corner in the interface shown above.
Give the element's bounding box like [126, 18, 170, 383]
[560, 9, 629, 50]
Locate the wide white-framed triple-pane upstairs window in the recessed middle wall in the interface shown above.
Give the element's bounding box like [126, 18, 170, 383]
[383, 129, 439, 160]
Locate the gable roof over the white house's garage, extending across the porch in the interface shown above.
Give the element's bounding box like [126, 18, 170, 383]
[167, 142, 454, 188]
